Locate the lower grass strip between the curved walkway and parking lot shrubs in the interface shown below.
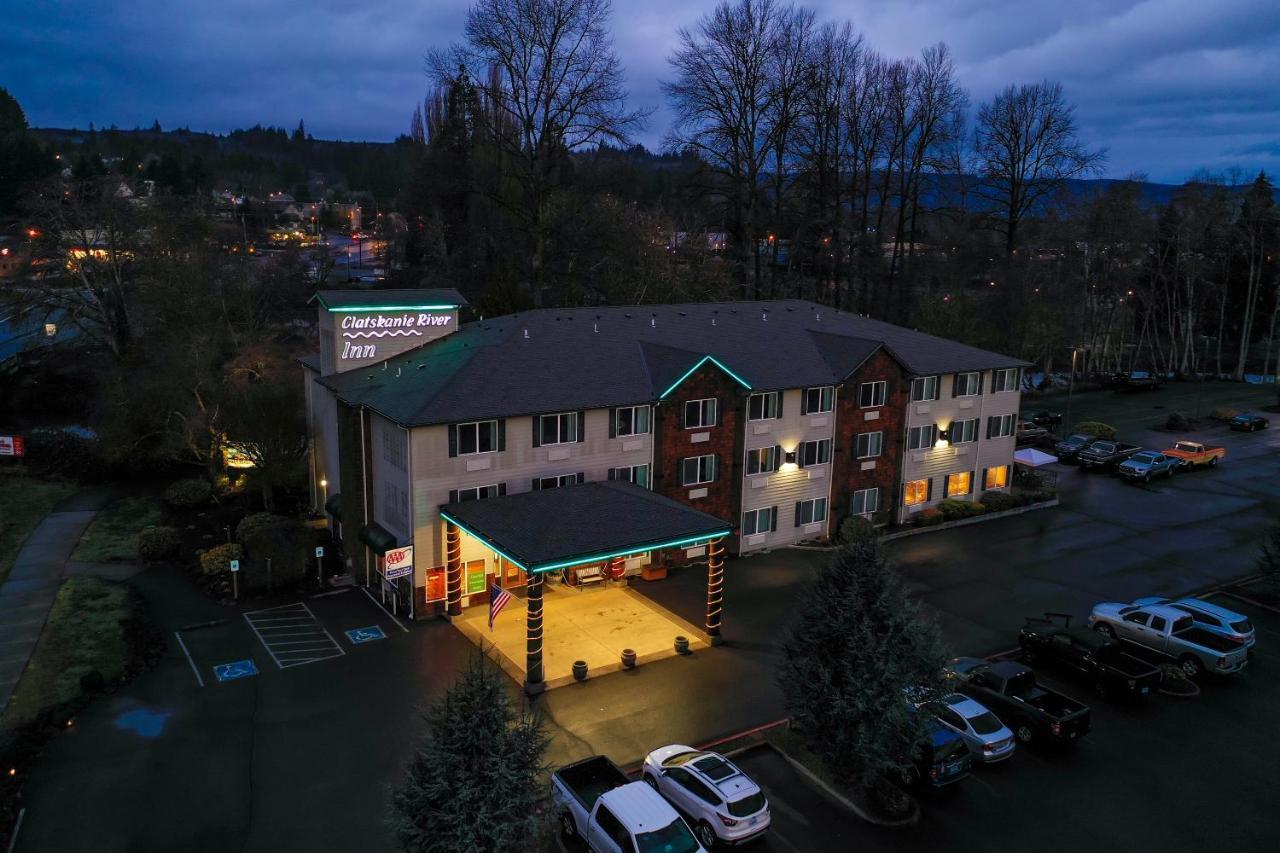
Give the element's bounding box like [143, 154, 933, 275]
[4, 578, 131, 725]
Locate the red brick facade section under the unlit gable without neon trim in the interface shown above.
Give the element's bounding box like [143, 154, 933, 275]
[831, 350, 911, 533]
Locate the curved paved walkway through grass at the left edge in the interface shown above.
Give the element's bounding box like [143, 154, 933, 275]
[0, 488, 114, 713]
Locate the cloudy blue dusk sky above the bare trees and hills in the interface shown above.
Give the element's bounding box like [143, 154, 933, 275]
[0, 0, 1280, 182]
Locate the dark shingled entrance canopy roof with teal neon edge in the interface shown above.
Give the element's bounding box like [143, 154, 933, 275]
[440, 480, 732, 574]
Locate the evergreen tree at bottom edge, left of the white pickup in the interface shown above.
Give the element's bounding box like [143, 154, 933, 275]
[392, 651, 547, 853]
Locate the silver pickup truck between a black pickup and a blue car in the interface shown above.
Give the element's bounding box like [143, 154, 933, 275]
[1089, 602, 1248, 676]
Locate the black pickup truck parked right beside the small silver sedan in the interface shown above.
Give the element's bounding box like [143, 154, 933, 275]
[943, 657, 1089, 744]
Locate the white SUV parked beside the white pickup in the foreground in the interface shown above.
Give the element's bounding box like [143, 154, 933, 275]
[641, 744, 769, 849]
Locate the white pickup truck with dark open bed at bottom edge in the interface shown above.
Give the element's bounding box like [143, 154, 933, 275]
[552, 756, 705, 853]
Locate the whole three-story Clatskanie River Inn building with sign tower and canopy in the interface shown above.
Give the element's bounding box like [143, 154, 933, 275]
[303, 289, 1025, 679]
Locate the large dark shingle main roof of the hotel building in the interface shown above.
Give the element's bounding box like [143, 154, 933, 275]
[323, 300, 1027, 427]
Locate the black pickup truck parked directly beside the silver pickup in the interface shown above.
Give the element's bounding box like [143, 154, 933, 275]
[1018, 613, 1160, 698]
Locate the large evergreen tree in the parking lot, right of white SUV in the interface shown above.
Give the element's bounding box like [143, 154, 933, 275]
[778, 540, 946, 785]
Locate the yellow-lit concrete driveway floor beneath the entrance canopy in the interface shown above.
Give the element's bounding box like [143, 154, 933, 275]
[453, 580, 708, 689]
